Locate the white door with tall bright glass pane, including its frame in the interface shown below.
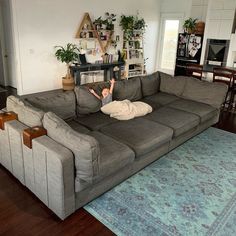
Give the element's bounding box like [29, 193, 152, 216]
[158, 17, 182, 74]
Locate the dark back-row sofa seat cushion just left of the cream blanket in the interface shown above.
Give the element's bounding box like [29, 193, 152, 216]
[74, 111, 117, 130]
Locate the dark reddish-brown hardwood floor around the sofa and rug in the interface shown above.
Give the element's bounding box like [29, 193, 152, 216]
[0, 87, 236, 236]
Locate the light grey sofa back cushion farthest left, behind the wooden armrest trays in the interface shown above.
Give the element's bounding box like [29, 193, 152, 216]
[7, 96, 44, 127]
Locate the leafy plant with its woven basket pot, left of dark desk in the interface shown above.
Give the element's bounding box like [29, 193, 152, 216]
[55, 43, 80, 90]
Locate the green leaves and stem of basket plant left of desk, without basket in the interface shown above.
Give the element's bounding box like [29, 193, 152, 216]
[55, 43, 80, 78]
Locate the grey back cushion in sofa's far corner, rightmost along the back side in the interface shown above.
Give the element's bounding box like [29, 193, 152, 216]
[140, 71, 160, 97]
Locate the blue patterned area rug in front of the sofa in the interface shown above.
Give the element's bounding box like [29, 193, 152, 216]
[85, 128, 236, 236]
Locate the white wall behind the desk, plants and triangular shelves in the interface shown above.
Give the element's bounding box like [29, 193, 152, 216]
[8, 0, 160, 95]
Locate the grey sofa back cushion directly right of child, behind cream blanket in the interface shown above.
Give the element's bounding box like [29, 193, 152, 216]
[113, 77, 142, 101]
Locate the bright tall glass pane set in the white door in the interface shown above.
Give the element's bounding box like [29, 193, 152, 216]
[161, 20, 179, 71]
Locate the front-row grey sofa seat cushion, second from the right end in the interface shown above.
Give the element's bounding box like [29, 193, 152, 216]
[145, 107, 200, 137]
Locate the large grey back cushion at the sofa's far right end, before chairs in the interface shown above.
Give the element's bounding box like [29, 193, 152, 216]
[182, 77, 228, 109]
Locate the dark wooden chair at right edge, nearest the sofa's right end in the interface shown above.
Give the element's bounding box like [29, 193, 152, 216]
[213, 67, 235, 110]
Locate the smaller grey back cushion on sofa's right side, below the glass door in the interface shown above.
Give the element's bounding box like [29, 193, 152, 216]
[159, 72, 187, 96]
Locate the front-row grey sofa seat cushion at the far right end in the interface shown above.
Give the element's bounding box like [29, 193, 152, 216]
[168, 99, 218, 123]
